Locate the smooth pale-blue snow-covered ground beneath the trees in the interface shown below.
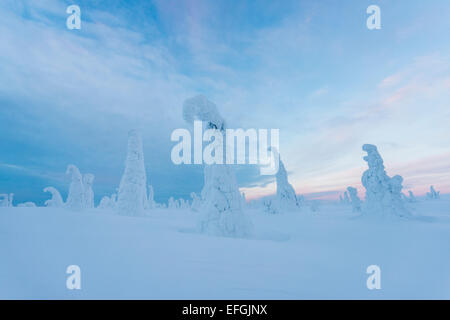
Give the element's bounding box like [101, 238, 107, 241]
[0, 197, 450, 299]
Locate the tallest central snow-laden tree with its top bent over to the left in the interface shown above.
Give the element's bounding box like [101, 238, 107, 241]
[183, 95, 252, 237]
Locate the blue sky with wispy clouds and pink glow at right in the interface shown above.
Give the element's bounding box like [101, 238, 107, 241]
[0, 0, 450, 205]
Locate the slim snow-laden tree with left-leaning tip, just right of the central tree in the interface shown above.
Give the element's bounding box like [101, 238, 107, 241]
[271, 148, 301, 212]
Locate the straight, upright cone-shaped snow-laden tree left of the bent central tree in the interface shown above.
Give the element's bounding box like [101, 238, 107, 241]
[116, 130, 147, 216]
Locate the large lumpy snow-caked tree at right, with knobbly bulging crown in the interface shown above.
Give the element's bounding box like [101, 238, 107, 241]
[361, 144, 410, 217]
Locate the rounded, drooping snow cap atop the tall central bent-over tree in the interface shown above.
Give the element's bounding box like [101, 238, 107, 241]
[183, 95, 225, 130]
